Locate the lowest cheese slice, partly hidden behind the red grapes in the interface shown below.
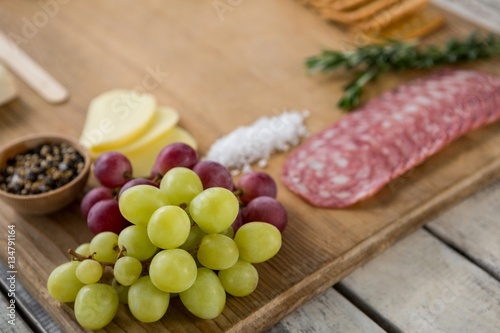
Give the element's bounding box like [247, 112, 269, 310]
[125, 126, 197, 177]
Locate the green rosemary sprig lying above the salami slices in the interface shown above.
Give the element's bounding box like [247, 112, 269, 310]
[305, 33, 500, 111]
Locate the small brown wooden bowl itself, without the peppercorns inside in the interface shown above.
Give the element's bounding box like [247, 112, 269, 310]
[0, 134, 91, 215]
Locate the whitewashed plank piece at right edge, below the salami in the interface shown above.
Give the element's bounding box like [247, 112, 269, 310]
[427, 182, 500, 280]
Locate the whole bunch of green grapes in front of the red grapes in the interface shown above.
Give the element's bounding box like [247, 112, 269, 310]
[47, 143, 286, 330]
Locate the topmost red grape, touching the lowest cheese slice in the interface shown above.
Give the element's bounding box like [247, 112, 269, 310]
[151, 142, 198, 178]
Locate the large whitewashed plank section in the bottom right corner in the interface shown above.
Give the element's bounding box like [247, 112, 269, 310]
[339, 230, 500, 333]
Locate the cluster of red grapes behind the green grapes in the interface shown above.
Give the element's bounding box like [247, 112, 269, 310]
[80, 142, 288, 234]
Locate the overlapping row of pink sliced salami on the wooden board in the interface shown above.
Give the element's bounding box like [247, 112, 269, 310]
[282, 70, 500, 208]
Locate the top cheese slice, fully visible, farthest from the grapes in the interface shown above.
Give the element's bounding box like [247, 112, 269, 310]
[80, 89, 156, 151]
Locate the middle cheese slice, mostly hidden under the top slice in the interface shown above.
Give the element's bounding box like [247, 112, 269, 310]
[90, 106, 180, 156]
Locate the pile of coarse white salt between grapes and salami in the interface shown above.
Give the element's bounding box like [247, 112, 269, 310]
[205, 111, 309, 175]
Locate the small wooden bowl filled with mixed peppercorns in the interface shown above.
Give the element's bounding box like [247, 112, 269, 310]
[0, 134, 91, 215]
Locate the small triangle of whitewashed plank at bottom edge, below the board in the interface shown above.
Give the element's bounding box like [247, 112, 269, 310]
[267, 288, 385, 333]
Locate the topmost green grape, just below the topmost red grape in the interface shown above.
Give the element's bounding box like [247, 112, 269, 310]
[160, 167, 203, 206]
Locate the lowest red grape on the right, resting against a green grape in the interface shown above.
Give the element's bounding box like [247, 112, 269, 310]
[243, 196, 288, 232]
